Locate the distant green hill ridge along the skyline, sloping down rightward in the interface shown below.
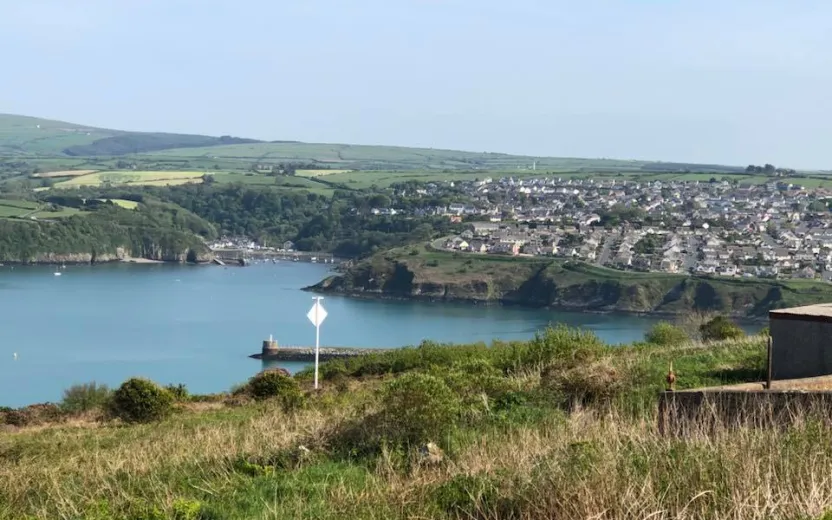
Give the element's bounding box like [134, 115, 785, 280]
[0, 114, 743, 173]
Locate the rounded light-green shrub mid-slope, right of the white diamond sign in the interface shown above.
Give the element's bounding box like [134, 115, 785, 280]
[380, 372, 460, 444]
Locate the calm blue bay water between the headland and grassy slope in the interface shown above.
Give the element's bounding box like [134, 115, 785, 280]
[0, 262, 668, 407]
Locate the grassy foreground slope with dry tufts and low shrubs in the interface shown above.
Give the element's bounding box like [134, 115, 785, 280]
[0, 328, 832, 519]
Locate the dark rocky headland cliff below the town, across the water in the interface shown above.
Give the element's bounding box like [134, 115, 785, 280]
[309, 248, 832, 317]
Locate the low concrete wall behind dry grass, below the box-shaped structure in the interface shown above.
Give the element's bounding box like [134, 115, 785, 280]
[659, 390, 832, 436]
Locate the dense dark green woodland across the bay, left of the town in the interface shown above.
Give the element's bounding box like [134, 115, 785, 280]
[0, 185, 459, 262]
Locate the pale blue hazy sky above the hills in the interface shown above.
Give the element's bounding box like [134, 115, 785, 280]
[0, 0, 832, 169]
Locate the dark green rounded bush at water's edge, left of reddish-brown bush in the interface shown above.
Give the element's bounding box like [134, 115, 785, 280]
[108, 377, 173, 423]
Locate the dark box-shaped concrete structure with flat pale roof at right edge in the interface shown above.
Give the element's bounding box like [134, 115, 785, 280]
[769, 304, 832, 380]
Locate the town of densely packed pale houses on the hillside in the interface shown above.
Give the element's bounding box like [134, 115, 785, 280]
[416, 177, 832, 280]
